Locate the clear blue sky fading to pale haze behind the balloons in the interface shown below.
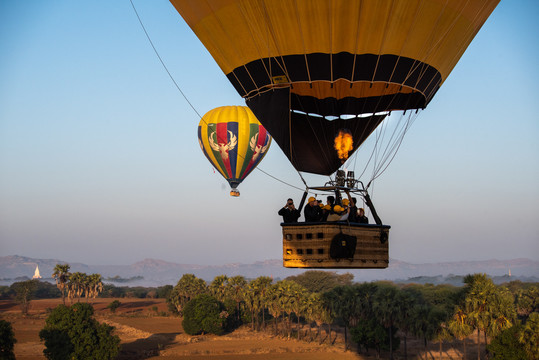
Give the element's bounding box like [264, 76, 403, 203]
[0, 0, 539, 264]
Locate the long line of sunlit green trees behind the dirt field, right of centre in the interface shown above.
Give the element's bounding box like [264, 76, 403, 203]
[168, 271, 539, 359]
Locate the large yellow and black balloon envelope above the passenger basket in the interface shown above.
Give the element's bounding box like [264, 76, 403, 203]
[175, 0, 499, 175]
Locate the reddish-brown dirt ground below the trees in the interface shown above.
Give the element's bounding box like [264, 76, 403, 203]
[0, 298, 486, 360]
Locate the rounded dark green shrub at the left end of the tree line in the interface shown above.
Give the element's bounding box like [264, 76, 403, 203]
[182, 294, 228, 335]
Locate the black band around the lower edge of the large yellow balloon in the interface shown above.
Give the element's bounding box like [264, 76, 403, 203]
[227, 52, 442, 112]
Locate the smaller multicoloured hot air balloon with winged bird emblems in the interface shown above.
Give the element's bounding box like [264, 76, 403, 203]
[198, 106, 271, 196]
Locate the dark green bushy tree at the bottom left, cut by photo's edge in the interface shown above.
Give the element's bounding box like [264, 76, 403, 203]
[39, 303, 120, 360]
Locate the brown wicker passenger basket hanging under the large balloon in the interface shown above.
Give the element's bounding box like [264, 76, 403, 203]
[281, 222, 390, 268]
